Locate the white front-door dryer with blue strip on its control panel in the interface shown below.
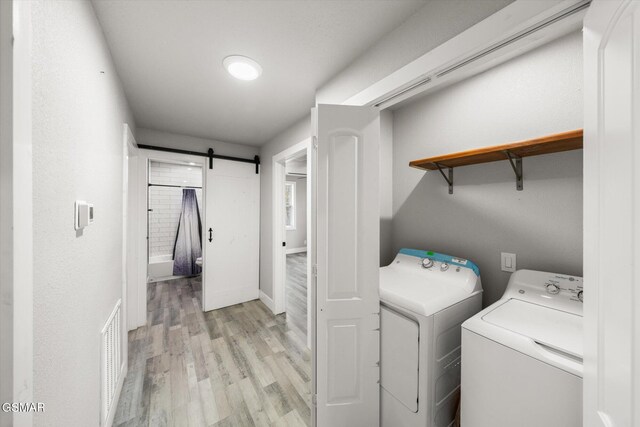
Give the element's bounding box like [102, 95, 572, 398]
[380, 249, 482, 427]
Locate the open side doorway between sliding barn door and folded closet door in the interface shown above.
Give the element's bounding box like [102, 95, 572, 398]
[273, 139, 312, 348]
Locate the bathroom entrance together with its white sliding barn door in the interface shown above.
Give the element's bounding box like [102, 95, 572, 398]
[134, 145, 260, 327]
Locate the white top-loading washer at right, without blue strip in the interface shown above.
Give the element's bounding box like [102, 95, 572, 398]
[461, 270, 583, 427]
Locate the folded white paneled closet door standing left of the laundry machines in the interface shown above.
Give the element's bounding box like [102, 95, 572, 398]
[312, 105, 380, 427]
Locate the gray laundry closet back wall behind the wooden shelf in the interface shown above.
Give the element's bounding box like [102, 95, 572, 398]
[392, 32, 583, 304]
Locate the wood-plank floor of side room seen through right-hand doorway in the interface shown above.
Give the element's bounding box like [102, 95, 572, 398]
[286, 252, 307, 341]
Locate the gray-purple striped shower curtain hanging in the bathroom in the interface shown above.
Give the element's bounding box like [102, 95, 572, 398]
[173, 188, 202, 276]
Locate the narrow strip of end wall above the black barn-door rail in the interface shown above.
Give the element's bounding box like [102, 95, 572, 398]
[136, 128, 260, 159]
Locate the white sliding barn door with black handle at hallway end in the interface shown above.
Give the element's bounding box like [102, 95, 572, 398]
[202, 159, 260, 311]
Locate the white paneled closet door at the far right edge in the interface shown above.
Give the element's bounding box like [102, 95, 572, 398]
[584, 0, 640, 427]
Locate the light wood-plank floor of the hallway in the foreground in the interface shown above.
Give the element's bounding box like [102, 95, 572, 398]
[114, 279, 311, 427]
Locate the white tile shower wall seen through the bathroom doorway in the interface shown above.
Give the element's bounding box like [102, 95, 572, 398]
[149, 162, 204, 257]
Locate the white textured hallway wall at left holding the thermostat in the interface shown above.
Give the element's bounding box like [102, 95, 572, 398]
[32, 1, 133, 426]
